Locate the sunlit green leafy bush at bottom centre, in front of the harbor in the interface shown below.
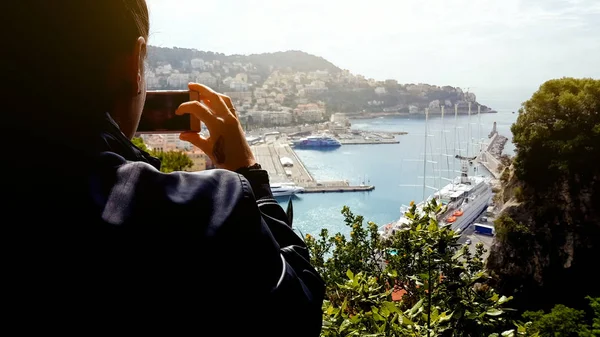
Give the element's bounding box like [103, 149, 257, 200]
[306, 200, 516, 336]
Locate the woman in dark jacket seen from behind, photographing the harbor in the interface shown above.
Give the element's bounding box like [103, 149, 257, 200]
[0, 0, 324, 336]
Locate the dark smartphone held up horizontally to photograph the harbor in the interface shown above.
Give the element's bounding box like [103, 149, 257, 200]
[137, 90, 201, 133]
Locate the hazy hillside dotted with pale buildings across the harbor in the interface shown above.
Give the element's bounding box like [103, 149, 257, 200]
[147, 46, 494, 117]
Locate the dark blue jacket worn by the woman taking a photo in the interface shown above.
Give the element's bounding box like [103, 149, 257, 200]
[2, 118, 324, 336]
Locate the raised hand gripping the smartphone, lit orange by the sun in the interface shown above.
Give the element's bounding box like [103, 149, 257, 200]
[176, 83, 256, 171]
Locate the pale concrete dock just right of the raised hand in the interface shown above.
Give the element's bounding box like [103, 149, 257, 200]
[251, 140, 375, 193]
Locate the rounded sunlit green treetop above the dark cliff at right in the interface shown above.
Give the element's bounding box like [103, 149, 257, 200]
[511, 78, 600, 193]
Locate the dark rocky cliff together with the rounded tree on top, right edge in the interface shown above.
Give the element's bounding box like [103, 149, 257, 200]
[488, 78, 600, 310]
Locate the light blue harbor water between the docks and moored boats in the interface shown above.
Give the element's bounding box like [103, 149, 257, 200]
[278, 92, 531, 236]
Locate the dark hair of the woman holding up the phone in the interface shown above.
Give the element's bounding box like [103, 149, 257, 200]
[0, 0, 150, 121]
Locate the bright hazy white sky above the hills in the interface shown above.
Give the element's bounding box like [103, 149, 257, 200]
[148, 0, 600, 98]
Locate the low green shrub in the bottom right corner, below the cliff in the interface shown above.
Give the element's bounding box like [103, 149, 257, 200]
[523, 297, 600, 337]
